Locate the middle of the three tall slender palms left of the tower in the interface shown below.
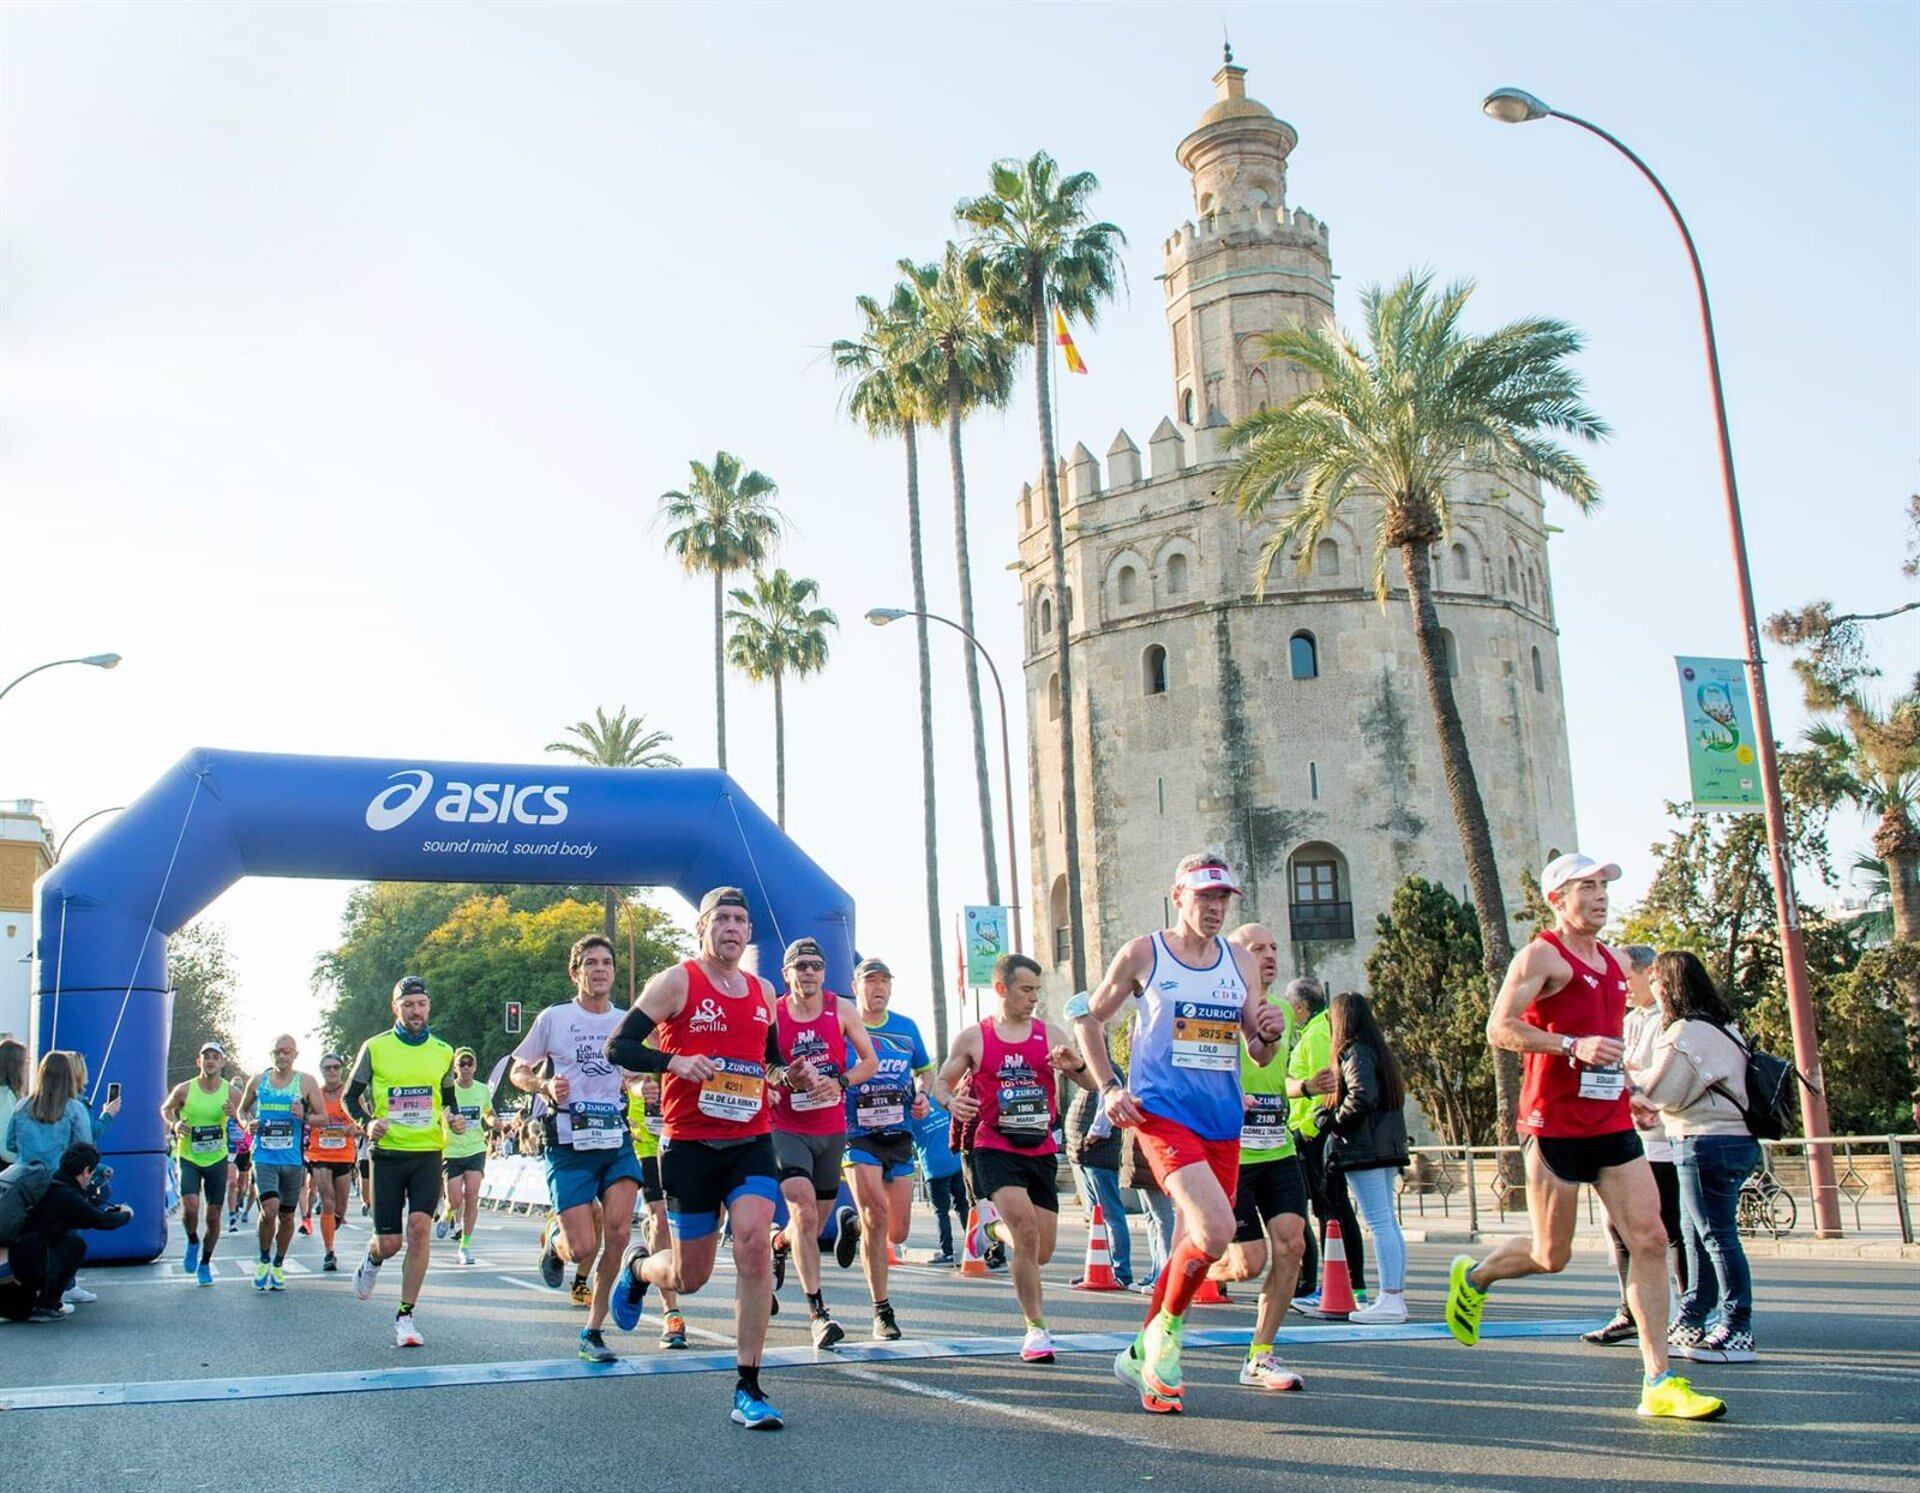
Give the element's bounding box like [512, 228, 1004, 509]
[900, 244, 1020, 904]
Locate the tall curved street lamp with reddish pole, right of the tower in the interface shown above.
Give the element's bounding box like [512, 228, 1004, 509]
[1480, 88, 1839, 1236]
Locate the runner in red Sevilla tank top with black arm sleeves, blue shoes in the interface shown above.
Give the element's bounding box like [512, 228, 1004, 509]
[607, 887, 783, 1430]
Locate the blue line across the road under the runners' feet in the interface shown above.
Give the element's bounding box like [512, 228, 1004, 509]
[0, 1318, 1599, 1410]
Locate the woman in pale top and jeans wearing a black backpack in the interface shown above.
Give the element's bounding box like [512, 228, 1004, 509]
[1634, 950, 1761, 1363]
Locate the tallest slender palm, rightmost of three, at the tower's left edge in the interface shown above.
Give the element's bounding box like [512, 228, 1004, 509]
[954, 150, 1127, 990]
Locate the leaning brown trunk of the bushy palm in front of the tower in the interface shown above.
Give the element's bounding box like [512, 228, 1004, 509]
[1400, 539, 1521, 1146]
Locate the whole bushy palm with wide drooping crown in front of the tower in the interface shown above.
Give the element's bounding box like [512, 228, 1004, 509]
[1225, 273, 1607, 1144]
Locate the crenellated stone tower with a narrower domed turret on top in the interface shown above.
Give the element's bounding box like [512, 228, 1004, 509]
[1020, 54, 1574, 994]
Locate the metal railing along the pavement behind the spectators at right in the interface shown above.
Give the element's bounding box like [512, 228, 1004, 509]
[1398, 1134, 1920, 1244]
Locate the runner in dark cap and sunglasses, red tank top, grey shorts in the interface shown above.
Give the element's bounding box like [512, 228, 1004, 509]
[774, 938, 879, 1347]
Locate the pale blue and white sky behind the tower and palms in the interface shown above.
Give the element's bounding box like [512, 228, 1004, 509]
[0, 2, 1920, 1046]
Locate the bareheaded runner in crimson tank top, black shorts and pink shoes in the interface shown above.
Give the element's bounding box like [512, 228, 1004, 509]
[933, 954, 1094, 1363]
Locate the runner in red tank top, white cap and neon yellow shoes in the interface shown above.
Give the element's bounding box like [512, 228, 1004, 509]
[1446, 854, 1726, 1420]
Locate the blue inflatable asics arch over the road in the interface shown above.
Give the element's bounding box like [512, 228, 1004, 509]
[35, 750, 854, 1261]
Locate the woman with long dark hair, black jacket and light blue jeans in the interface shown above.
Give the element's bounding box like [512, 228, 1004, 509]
[1319, 990, 1407, 1324]
